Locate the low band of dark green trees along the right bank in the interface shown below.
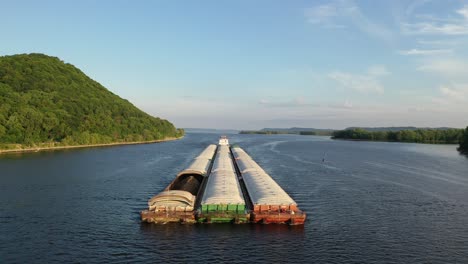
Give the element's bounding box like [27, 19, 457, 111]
[333, 128, 463, 144]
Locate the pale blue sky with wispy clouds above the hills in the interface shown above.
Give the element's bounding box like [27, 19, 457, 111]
[0, 0, 468, 129]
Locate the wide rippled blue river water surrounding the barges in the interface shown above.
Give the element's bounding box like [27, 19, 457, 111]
[0, 133, 468, 263]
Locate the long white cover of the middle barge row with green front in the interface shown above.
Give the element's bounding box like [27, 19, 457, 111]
[201, 146, 245, 205]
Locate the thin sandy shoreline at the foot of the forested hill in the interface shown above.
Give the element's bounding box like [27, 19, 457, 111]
[0, 136, 184, 155]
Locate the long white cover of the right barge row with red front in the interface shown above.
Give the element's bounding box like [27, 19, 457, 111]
[232, 147, 296, 205]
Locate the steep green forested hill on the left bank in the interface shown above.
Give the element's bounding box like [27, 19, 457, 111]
[0, 54, 183, 151]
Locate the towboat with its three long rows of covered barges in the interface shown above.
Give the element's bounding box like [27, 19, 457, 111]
[141, 137, 306, 225]
